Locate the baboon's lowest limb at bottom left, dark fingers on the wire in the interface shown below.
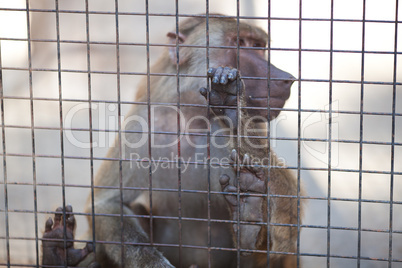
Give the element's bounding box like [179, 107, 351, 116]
[42, 203, 173, 268]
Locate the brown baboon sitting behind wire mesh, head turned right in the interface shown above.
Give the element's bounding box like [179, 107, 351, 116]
[44, 15, 298, 267]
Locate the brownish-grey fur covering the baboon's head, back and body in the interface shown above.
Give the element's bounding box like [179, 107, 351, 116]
[42, 14, 304, 267]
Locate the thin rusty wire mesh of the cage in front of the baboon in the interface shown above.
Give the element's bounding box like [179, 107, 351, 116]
[0, 0, 402, 267]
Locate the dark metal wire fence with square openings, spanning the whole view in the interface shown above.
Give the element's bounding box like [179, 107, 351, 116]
[0, 0, 402, 268]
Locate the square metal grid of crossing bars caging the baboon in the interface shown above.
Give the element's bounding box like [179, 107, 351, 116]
[0, 0, 402, 267]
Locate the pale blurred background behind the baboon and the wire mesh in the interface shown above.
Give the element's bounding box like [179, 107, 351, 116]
[0, 0, 402, 267]
